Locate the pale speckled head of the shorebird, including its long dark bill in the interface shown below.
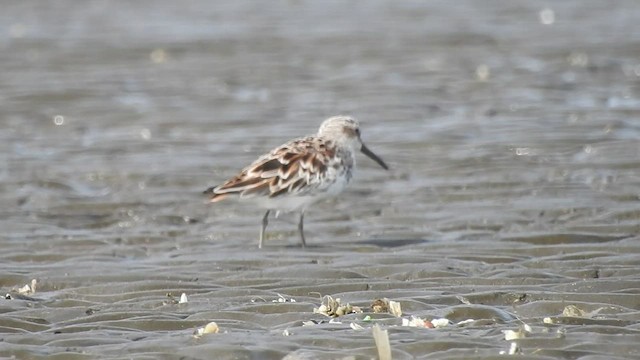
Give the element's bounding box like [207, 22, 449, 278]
[318, 115, 389, 170]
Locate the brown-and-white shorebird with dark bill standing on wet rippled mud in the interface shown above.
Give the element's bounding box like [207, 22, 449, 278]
[204, 115, 389, 248]
